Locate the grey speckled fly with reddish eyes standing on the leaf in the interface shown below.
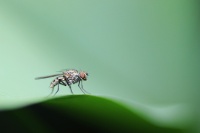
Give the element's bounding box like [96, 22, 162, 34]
[35, 69, 88, 95]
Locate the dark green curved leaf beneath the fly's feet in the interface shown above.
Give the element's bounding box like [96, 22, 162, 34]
[0, 95, 188, 133]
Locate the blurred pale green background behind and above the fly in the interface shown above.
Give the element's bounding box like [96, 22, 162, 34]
[0, 0, 200, 131]
